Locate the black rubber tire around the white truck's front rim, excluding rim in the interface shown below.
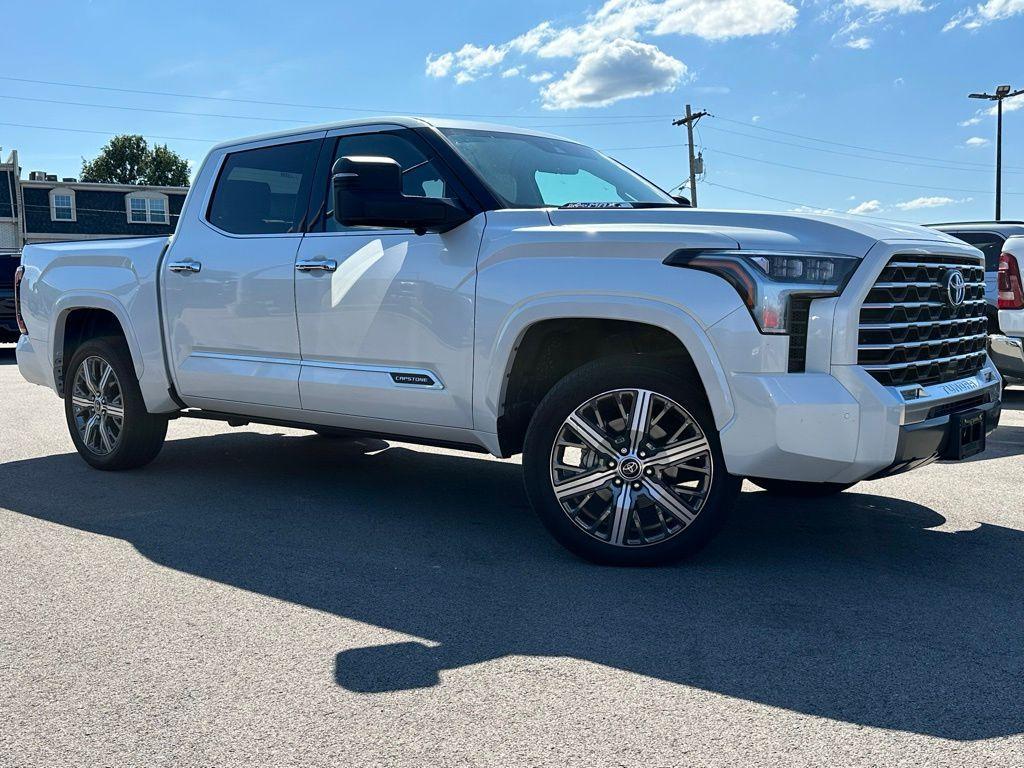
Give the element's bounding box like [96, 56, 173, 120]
[523, 355, 741, 565]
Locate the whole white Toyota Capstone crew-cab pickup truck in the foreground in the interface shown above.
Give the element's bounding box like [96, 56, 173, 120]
[17, 118, 1000, 564]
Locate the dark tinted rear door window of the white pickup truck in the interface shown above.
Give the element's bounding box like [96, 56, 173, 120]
[207, 141, 319, 234]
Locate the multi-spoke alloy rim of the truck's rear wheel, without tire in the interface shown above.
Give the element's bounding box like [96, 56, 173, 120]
[72, 356, 125, 456]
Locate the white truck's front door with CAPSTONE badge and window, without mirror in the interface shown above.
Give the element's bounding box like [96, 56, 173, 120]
[295, 128, 483, 427]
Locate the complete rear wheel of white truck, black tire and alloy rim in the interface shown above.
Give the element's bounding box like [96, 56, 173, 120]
[65, 337, 167, 470]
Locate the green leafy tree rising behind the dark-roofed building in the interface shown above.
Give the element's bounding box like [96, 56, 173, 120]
[82, 134, 188, 186]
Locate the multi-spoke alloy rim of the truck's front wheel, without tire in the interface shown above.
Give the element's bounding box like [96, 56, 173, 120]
[551, 389, 715, 547]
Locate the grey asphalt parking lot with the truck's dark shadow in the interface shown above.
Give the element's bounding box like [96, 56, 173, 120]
[0, 348, 1024, 768]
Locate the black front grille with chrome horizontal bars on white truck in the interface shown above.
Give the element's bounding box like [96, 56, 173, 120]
[857, 255, 988, 387]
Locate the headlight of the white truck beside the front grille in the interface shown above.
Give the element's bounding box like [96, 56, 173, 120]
[665, 249, 860, 334]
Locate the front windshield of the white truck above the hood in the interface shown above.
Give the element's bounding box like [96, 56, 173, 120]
[441, 128, 678, 208]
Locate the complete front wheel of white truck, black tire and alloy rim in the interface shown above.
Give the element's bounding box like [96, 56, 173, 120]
[523, 355, 740, 565]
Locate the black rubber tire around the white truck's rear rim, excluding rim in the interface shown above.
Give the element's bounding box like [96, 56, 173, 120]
[65, 336, 167, 471]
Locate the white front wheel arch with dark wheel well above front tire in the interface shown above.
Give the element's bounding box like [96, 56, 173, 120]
[477, 296, 734, 456]
